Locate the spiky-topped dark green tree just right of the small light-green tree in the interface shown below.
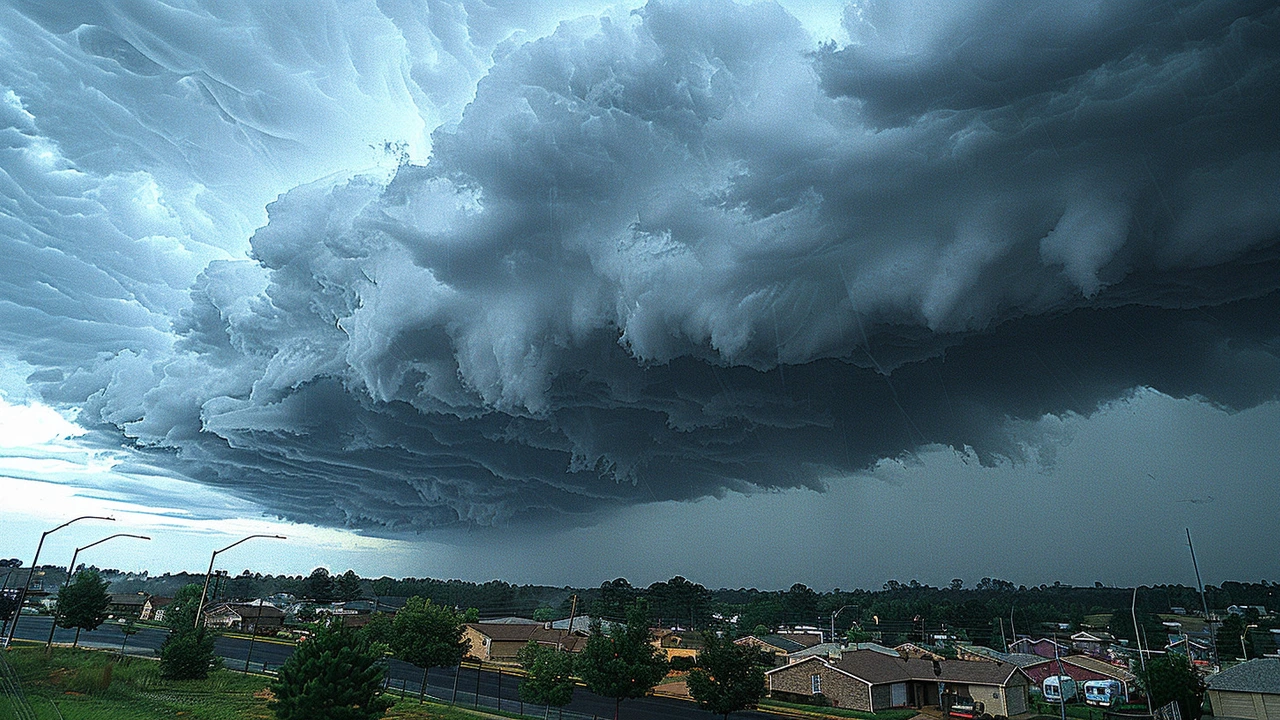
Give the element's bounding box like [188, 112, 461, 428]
[577, 600, 667, 720]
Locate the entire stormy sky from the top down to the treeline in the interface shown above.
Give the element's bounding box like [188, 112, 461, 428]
[0, 0, 1280, 588]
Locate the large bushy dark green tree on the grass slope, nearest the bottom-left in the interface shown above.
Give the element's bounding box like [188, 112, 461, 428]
[271, 626, 392, 720]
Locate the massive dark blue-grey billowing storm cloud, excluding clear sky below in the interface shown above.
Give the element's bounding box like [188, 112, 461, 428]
[0, 1, 1280, 528]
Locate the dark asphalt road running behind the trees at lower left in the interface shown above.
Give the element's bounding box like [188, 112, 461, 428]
[2, 615, 777, 720]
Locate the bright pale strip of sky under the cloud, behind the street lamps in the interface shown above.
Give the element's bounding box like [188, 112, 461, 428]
[0, 396, 430, 577]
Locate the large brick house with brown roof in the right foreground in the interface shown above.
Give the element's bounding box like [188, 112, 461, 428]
[764, 650, 1030, 716]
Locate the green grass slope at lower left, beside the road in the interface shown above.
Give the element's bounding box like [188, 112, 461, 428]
[0, 647, 509, 720]
